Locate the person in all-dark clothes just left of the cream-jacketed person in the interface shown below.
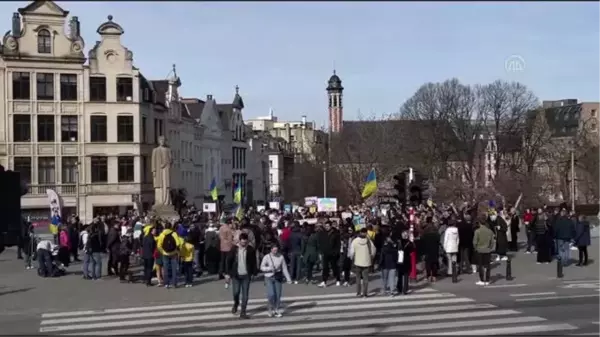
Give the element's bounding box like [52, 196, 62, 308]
[319, 221, 342, 288]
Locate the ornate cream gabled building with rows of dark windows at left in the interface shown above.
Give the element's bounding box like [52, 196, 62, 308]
[0, 1, 200, 221]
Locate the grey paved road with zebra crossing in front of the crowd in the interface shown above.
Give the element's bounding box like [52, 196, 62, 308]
[0, 228, 600, 335]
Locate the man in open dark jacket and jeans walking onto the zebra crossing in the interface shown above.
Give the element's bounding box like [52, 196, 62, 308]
[225, 233, 258, 319]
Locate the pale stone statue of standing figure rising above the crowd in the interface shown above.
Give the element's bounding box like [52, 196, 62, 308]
[152, 136, 173, 208]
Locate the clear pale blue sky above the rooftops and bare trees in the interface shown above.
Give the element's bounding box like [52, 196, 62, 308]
[0, 1, 600, 124]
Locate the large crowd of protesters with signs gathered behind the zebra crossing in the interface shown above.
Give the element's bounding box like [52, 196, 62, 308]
[18, 200, 591, 317]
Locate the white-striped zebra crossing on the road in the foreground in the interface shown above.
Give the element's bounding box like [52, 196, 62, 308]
[39, 287, 578, 336]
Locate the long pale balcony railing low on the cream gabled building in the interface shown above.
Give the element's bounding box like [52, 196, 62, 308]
[24, 183, 152, 197]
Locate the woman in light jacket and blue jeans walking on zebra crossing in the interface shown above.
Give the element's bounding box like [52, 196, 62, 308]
[260, 243, 292, 317]
